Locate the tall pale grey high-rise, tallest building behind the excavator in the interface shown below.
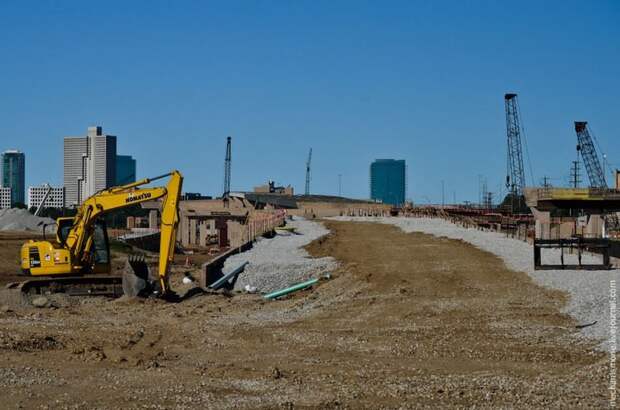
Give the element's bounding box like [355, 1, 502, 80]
[64, 127, 116, 207]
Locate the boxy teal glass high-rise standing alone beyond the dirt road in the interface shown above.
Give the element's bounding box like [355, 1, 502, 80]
[370, 159, 407, 205]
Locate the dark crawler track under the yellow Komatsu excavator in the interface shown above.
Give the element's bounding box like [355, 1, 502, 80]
[6, 275, 123, 297]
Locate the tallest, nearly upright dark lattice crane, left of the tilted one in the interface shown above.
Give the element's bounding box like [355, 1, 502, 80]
[504, 94, 525, 196]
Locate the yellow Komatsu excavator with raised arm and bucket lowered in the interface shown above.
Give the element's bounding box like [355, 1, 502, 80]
[18, 171, 183, 297]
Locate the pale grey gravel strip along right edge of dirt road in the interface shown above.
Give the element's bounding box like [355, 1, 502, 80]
[333, 217, 620, 351]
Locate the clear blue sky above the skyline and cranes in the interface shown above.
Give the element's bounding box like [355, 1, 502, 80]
[0, 0, 620, 202]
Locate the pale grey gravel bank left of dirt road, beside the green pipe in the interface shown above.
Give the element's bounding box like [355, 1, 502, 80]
[224, 218, 337, 293]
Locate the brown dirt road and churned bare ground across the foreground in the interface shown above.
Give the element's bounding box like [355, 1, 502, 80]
[0, 222, 608, 409]
